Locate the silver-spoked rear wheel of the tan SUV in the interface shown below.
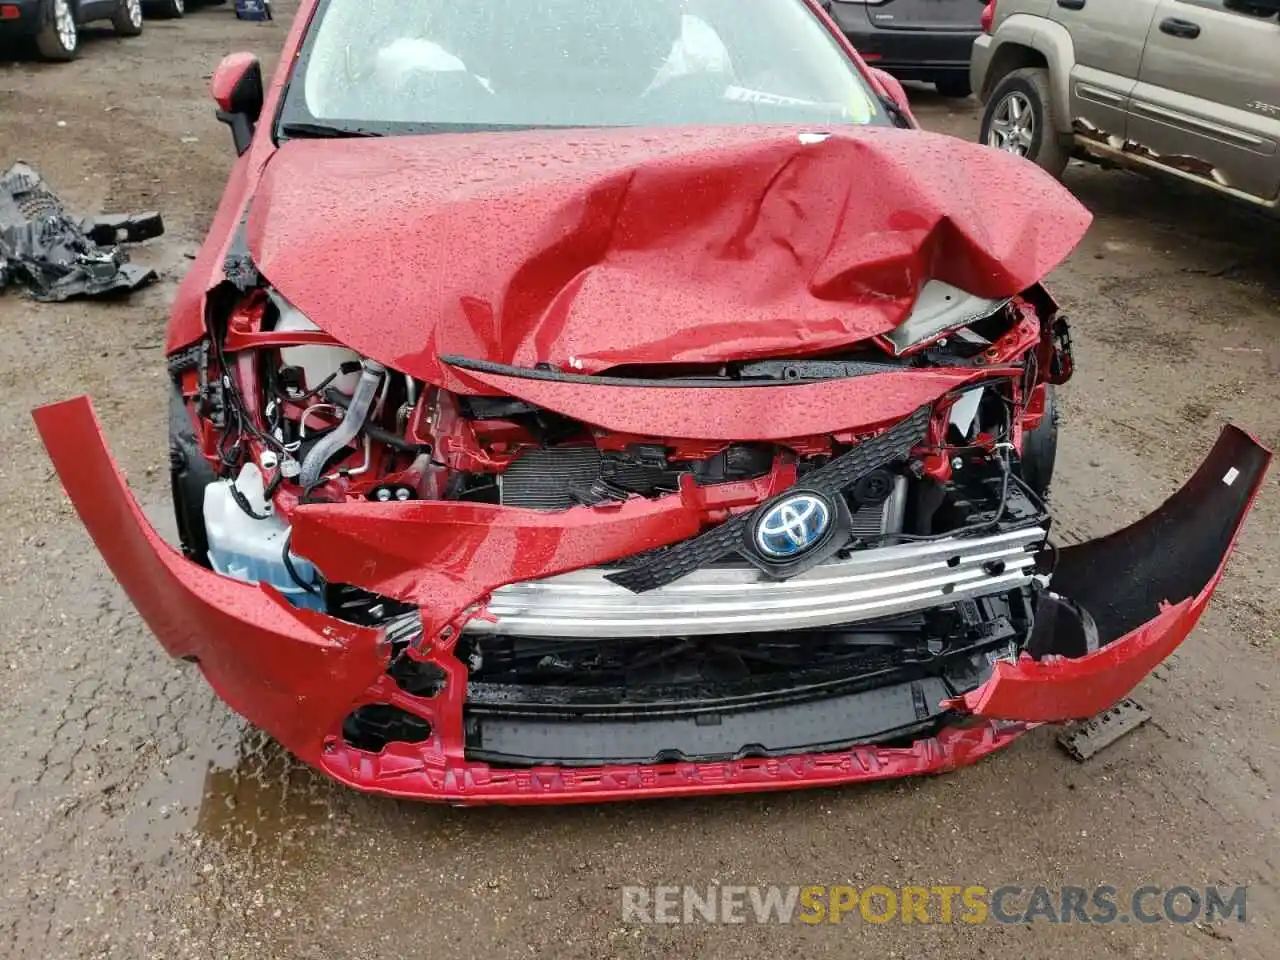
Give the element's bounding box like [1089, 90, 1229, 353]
[978, 67, 1070, 177]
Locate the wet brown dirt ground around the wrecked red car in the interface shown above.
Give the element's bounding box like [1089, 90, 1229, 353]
[0, 3, 1280, 960]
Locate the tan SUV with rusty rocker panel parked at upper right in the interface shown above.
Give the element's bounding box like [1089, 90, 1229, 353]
[972, 0, 1280, 210]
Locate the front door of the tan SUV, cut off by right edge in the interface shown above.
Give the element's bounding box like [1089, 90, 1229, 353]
[1128, 0, 1280, 200]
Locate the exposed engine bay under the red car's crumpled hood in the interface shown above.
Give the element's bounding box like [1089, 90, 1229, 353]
[170, 281, 1070, 609]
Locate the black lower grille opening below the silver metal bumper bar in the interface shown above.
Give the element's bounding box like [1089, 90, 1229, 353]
[458, 591, 1030, 767]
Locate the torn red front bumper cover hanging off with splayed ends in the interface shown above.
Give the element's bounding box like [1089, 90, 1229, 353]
[35, 398, 1271, 804]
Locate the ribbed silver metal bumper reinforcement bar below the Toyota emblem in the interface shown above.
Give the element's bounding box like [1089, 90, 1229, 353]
[466, 526, 1046, 639]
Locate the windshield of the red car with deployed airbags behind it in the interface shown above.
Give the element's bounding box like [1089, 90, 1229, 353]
[282, 0, 887, 136]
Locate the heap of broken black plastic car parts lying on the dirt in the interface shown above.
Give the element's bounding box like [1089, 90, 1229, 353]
[0, 164, 164, 302]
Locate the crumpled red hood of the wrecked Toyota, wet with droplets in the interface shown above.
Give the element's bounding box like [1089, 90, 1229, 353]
[247, 127, 1091, 383]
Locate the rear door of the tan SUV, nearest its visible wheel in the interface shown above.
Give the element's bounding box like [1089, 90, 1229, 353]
[1050, 0, 1160, 146]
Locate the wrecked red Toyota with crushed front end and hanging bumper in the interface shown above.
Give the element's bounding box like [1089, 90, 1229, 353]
[35, 0, 1270, 804]
